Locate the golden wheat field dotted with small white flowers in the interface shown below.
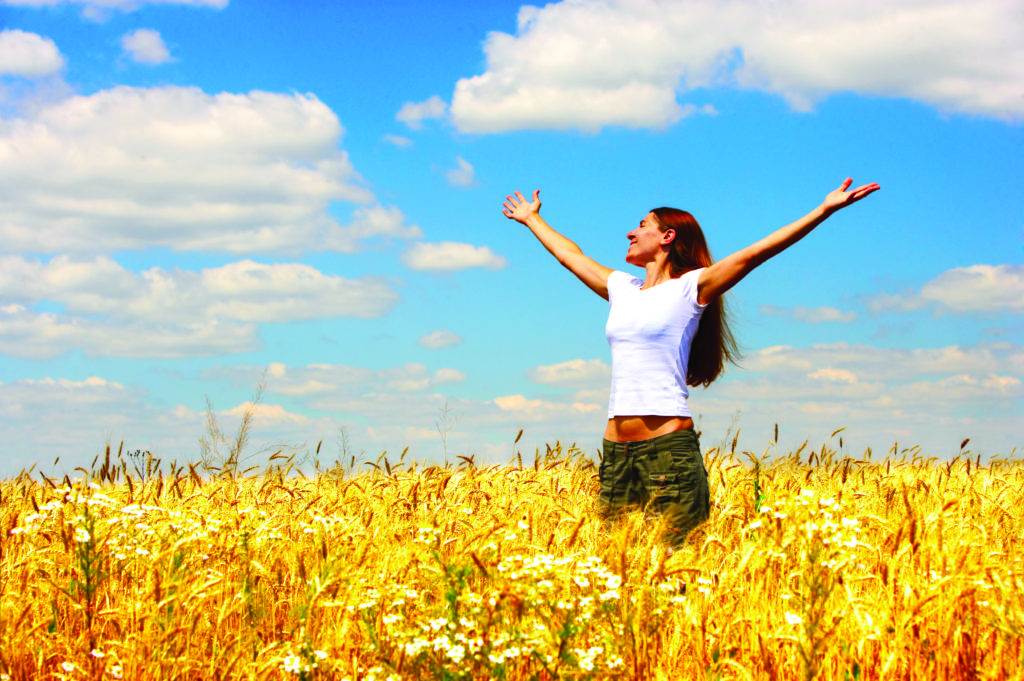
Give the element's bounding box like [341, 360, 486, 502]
[0, 437, 1024, 680]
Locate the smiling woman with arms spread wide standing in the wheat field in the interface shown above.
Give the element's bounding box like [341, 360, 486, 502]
[502, 178, 879, 546]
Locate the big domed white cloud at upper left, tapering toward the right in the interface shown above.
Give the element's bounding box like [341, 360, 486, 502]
[0, 87, 420, 254]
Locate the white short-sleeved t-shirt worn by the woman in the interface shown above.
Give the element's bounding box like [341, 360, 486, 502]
[604, 268, 707, 419]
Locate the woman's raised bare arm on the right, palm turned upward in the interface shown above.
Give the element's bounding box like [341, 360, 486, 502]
[697, 177, 880, 303]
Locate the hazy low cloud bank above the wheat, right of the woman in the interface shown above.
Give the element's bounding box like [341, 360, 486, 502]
[691, 343, 1024, 456]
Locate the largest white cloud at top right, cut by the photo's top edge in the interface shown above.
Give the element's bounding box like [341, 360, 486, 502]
[451, 0, 1024, 133]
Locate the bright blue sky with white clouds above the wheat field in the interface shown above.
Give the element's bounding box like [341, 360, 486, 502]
[0, 0, 1024, 473]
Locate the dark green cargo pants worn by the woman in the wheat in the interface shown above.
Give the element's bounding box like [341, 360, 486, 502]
[598, 430, 711, 546]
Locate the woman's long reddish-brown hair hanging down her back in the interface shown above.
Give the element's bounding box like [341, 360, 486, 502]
[651, 207, 739, 386]
